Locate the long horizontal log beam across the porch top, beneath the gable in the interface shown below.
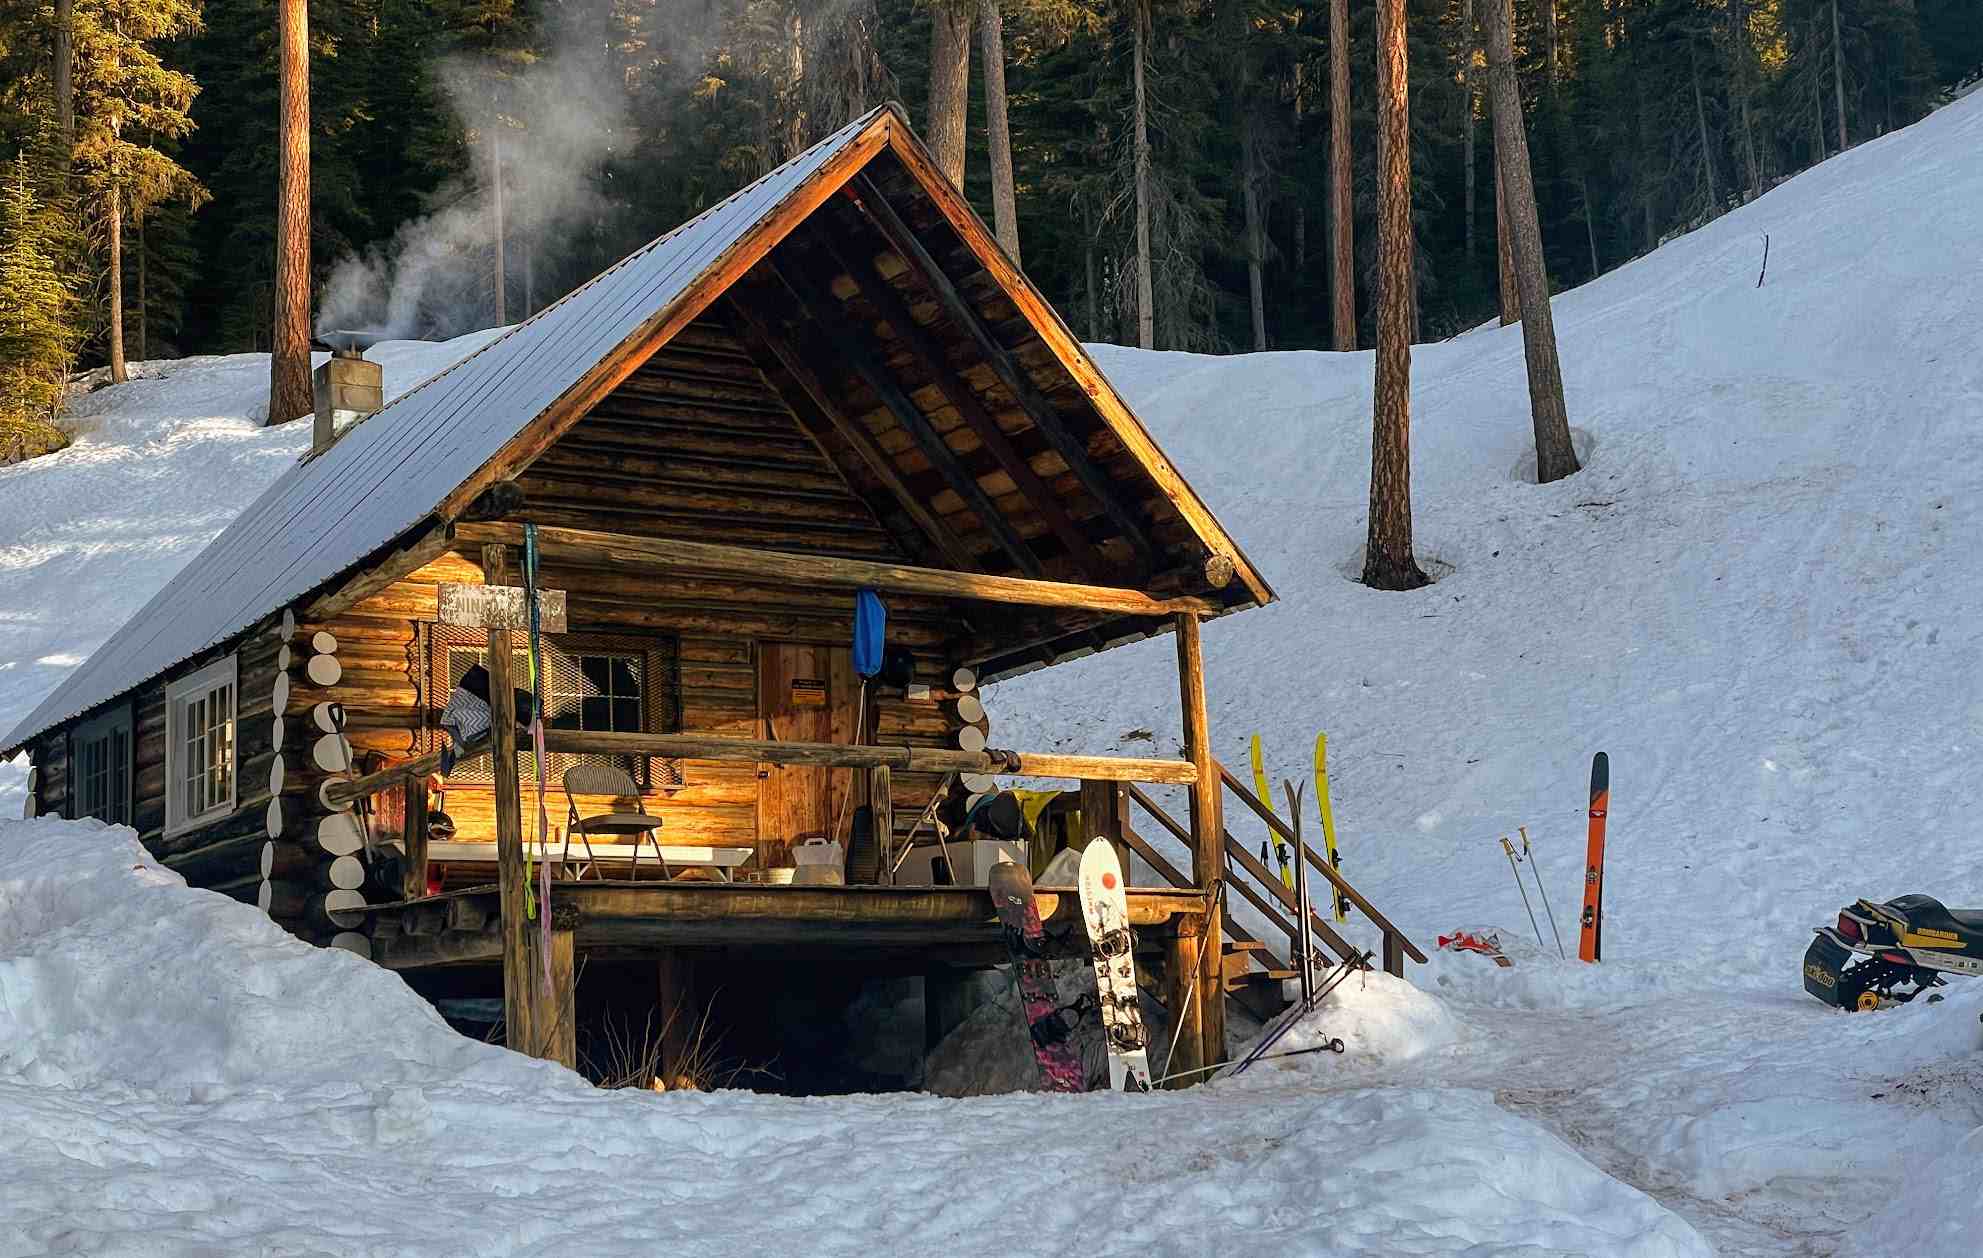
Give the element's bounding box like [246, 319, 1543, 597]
[456, 524, 1220, 615]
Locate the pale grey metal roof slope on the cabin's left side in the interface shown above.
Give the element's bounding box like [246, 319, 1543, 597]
[0, 105, 890, 750]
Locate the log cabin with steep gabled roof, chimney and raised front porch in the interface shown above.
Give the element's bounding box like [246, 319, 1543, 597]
[0, 105, 1418, 1068]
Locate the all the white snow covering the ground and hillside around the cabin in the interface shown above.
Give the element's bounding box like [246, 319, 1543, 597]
[0, 93, 1983, 1258]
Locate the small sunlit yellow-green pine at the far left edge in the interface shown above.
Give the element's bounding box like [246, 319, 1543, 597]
[0, 153, 79, 466]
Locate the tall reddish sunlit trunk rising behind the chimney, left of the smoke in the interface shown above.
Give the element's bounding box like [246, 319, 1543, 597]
[268, 0, 313, 425]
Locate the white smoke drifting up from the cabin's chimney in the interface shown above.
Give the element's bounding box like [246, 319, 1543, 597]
[317, 20, 627, 339]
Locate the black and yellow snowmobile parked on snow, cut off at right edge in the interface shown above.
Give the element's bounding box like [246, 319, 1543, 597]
[1805, 895, 1983, 1010]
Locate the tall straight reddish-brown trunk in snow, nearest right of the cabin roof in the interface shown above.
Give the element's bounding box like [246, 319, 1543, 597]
[1364, 0, 1426, 589]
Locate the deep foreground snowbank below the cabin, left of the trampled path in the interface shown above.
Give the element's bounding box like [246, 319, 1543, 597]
[0, 819, 1707, 1258]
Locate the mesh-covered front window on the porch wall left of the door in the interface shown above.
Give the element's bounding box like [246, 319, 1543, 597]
[430, 625, 682, 790]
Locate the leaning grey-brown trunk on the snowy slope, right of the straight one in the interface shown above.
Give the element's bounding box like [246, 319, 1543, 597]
[1483, 0, 1578, 484]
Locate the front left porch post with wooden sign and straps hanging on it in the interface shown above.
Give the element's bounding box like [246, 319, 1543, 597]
[482, 546, 575, 1066]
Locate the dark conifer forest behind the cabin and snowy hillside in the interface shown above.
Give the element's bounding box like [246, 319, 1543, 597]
[0, 0, 1983, 446]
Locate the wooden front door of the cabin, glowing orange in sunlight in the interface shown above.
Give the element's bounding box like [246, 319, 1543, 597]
[756, 643, 861, 869]
